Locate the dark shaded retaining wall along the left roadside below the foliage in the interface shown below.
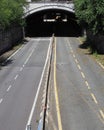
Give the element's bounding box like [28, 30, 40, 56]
[0, 25, 23, 55]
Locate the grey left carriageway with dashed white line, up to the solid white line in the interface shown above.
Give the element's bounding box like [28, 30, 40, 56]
[0, 38, 50, 130]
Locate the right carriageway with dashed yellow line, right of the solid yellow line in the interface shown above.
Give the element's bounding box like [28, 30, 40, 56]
[56, 38, 104, 130]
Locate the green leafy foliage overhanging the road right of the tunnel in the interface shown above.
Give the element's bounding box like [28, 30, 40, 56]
[74, 0, 104, 35]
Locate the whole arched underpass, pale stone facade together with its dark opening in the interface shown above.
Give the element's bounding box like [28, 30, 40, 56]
[25, 2, 82, 37]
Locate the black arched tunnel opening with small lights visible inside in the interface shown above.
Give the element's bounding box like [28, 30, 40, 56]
[25, 10, 82, 37]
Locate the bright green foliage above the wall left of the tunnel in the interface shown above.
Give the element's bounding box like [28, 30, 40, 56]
[0, 0, 26, 28]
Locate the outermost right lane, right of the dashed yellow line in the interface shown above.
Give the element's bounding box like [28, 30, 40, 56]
[66, 38, 104, 108]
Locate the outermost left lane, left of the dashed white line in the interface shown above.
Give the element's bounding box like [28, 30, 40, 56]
[0, 40, 37, 99]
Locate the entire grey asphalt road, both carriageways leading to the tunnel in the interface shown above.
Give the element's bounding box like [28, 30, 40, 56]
[0, 37, 104, 130]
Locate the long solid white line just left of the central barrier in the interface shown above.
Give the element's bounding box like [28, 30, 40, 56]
[26, 37, 51, 130]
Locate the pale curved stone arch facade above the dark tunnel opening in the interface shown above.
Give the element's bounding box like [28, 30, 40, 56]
[24, 2, 75, 17]
